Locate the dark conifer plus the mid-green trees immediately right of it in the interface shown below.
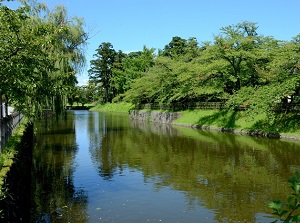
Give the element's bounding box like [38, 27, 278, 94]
[89, 43, 154, 103]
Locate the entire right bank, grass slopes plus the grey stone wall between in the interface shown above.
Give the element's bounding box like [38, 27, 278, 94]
[91, 103, 300, 140]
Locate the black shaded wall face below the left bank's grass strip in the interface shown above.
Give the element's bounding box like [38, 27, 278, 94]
[0, 125, 33, 223]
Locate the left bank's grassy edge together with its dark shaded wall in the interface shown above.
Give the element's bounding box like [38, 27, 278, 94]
[0, 120, 33, 222]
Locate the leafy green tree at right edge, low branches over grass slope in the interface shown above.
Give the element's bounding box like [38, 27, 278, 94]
[228, 34, 300, 117]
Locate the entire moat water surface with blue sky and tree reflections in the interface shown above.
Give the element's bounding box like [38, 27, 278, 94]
[31, 111, 300, 223]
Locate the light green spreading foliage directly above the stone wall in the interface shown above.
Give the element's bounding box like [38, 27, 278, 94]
[120, 53, 224, 104]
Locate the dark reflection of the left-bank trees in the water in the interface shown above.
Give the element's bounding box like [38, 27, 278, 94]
[32, 113, 88, 223]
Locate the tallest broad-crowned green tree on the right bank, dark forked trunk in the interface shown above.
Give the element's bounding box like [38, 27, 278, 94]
[200, 21, 273, 94]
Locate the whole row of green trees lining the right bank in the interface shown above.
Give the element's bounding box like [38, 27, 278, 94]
[89, 21, 300, 116]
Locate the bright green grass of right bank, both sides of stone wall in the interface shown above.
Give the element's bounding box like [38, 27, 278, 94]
[92, 103, 300, 137]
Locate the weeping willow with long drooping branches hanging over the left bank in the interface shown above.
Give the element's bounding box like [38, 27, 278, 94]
[47, 6, 88, 115]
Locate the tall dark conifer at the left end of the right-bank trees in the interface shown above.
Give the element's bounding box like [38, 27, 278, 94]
[88, 42, 117, 103]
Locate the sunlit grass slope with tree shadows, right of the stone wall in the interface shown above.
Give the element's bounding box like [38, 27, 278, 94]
[172, 110, 300, 140]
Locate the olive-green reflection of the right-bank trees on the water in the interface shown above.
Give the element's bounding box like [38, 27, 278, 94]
[90, 115, 300, 222]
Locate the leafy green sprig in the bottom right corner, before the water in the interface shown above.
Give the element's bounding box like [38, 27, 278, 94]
[269, 172, 300, 222]
